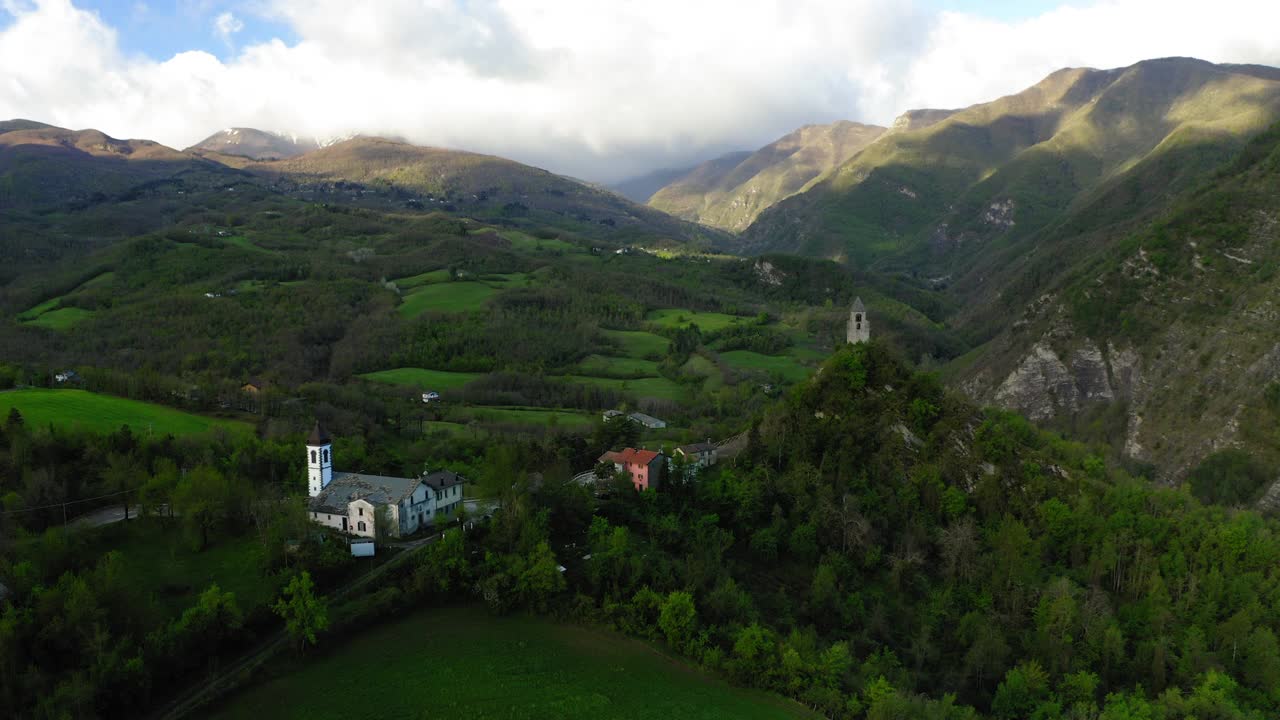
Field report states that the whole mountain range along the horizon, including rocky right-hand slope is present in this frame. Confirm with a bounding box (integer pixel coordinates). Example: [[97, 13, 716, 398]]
[[0, 58, 1280, 486]]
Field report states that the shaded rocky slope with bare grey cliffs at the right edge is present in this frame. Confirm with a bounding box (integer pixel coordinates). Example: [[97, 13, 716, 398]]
[[956, 119, 1280, 486]]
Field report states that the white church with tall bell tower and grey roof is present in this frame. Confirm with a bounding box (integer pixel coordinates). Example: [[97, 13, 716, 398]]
[[307, 423, 466, 539]]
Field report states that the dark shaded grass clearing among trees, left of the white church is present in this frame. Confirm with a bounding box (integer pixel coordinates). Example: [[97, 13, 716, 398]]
[[88, 518, 279, 616]]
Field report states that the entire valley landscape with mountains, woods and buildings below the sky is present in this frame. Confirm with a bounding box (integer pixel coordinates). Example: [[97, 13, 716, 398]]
[[0, 41, 1280, 720]]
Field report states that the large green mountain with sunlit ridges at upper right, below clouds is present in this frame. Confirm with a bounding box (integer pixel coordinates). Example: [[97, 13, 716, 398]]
[[741, 58, 1280, 267]]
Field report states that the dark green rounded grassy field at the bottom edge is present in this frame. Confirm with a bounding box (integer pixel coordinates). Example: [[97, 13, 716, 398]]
[[207, 607, 813, 720]]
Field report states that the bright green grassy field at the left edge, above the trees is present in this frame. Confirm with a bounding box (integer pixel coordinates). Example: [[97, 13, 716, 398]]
[[0, 388, 250, 436]]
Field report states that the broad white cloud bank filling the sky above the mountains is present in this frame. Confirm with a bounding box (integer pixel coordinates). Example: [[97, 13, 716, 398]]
[[0, 0, 1280, 179]]
